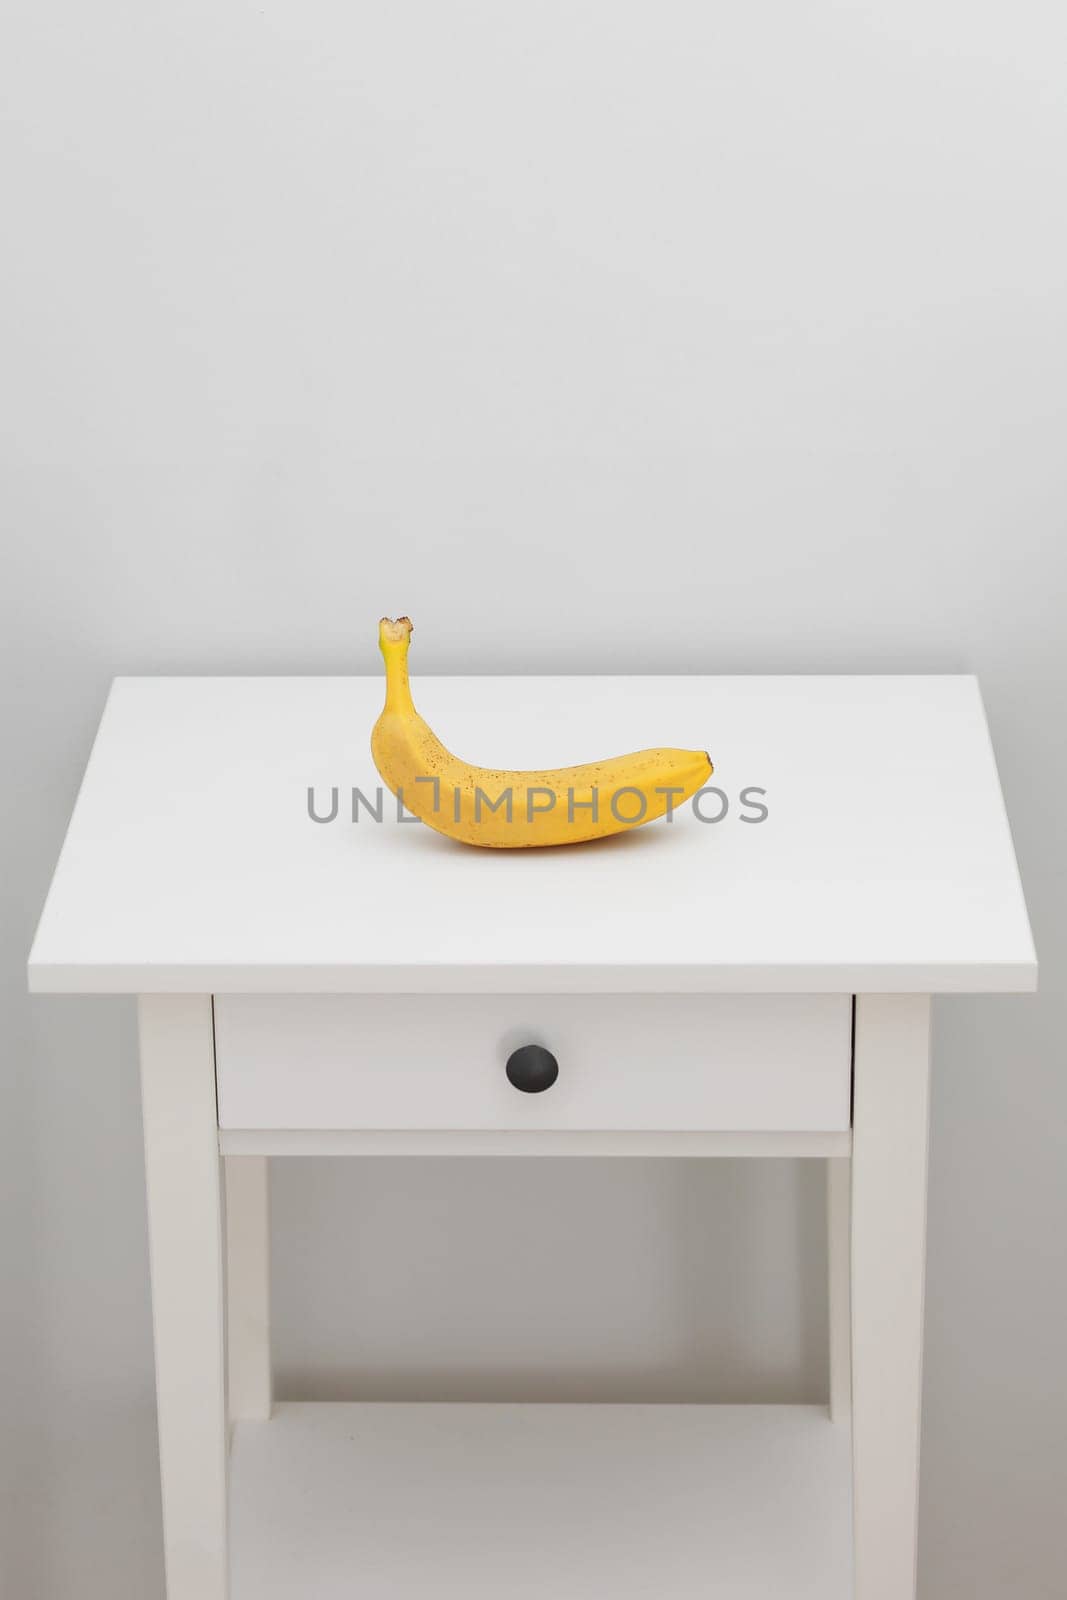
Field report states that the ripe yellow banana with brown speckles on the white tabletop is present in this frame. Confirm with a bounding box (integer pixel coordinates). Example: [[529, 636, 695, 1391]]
[[371, 616, 712, 850]]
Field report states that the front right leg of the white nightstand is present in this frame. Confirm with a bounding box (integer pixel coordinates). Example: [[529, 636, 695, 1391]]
[[853, 995, 929, 1600]]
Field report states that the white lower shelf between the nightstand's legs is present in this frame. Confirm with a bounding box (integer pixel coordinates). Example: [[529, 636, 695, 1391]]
[[230, 1403, 851, 1600]]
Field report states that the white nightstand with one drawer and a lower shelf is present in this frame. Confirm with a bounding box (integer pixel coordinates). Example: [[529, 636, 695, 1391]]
[[30, 677, 1037, 1600]]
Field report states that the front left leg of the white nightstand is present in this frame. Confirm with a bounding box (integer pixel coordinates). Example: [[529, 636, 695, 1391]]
[[139, 995, 229, 1600]]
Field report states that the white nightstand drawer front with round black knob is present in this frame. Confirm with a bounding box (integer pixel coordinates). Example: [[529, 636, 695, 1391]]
[[214, 995, 853, 1133]]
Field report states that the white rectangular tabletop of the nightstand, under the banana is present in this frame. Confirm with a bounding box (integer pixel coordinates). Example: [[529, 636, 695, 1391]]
[[30, 677, 1037, 994]]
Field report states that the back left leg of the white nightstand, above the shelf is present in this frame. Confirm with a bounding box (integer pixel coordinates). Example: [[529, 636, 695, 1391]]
[[224, 1155, 272, 1422]]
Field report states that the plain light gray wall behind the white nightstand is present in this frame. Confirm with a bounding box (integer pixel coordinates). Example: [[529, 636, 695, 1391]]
[[0, 0, 1067, 1600]]
